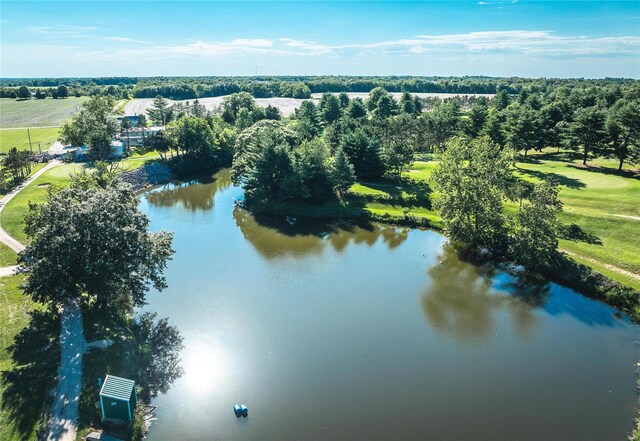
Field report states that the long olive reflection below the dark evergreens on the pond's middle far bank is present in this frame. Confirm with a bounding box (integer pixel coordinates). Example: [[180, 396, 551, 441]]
[[233, 208, 410, 259]]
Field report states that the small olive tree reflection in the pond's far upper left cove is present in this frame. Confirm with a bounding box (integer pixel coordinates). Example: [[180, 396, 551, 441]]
[[145, 169, 231, 211]]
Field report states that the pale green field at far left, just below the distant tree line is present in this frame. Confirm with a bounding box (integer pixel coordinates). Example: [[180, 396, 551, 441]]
[[0, 97, 89, 129]]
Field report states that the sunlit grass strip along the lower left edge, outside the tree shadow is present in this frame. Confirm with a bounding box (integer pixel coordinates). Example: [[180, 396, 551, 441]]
[[0, 275, 42, 441]]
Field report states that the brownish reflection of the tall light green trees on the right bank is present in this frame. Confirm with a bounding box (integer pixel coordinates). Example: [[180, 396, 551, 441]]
[[422, 244, 549, 344]]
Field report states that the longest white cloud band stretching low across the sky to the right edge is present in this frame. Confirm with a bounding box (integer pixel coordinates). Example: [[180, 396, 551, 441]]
[[46, 30, 640, 66]]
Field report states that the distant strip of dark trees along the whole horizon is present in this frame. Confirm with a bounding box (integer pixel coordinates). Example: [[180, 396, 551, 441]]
[[0, 76, 637, 100]]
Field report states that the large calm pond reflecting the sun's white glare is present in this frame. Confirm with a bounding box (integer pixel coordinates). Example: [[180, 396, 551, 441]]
[[141, 171, 640, 441]]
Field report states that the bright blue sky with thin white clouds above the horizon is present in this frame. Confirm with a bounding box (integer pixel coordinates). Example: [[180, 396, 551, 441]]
[[0, 0, 640, 78]]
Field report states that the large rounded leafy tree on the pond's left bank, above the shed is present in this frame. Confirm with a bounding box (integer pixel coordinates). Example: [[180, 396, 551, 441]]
[[24, 181, 173, 306]]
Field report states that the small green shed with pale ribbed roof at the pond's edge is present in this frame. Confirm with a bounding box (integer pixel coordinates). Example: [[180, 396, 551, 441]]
[[100, 375, 138, 422]]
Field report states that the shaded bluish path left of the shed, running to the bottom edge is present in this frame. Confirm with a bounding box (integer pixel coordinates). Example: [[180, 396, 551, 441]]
[[47, 300, 87, 441]]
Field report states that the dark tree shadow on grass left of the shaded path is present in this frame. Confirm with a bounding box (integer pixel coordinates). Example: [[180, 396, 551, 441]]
[[0, 311, 60, 440]]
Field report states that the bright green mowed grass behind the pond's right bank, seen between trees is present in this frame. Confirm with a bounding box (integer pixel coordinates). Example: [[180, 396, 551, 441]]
[[352, 153, 640, 290]]
